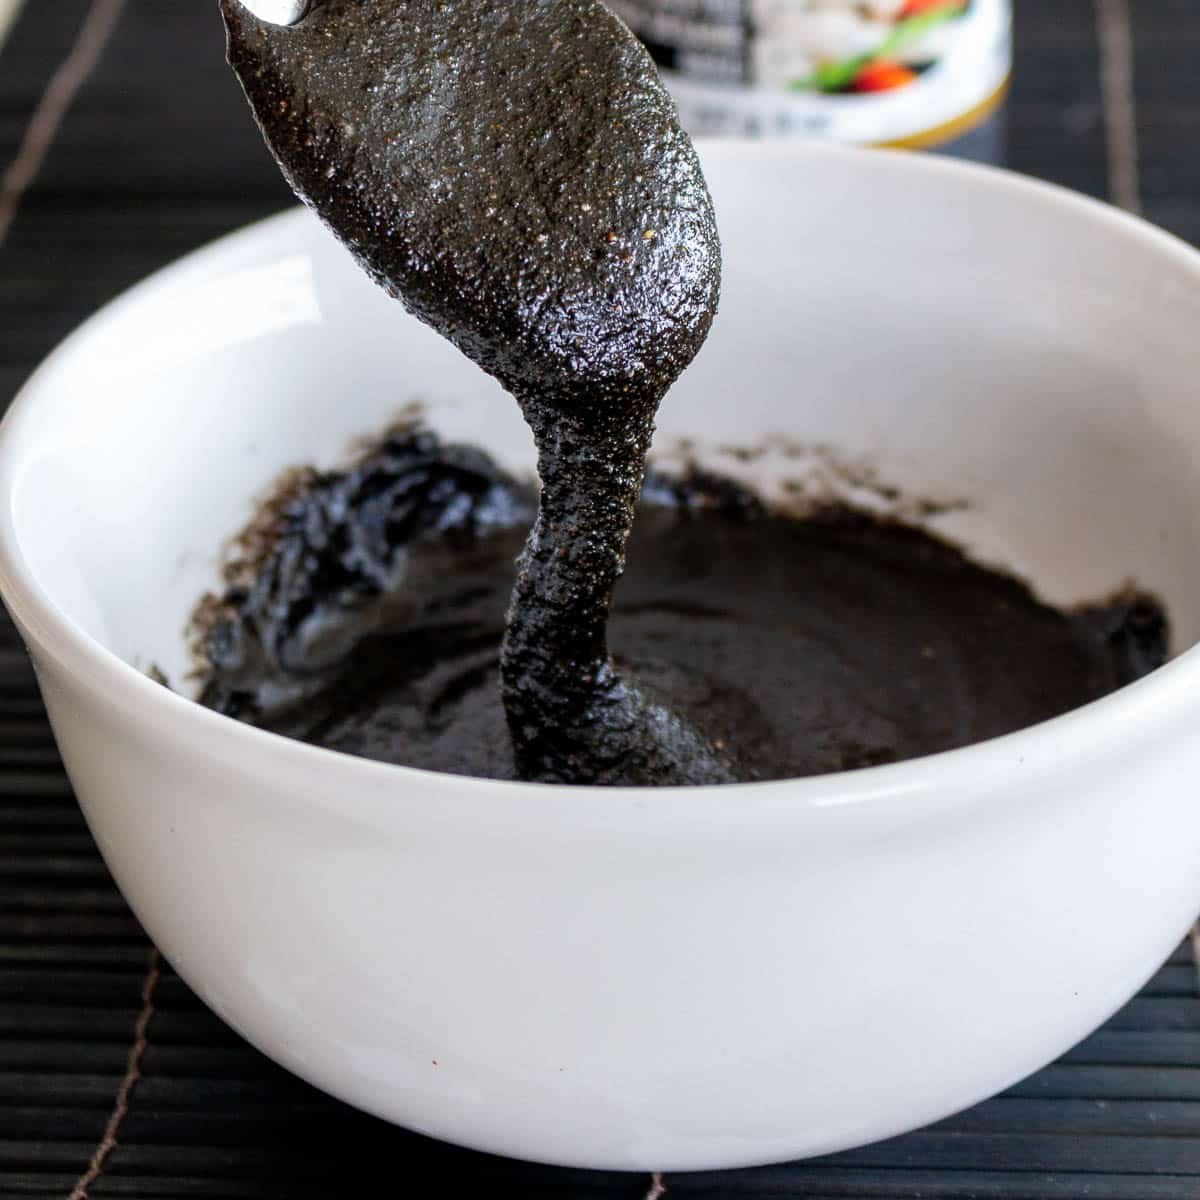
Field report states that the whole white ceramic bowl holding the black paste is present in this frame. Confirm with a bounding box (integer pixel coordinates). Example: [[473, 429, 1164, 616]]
[[0, 145, 1200, 1169]]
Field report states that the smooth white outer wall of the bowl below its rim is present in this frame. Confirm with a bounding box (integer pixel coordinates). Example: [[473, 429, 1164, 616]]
[[28, 643, 1200, 1170]]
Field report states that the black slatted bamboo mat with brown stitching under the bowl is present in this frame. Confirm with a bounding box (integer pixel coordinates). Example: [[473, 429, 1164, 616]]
[[0, 0, 1200, 1200]]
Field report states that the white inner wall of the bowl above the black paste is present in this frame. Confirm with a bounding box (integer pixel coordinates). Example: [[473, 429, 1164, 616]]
[[2, 144, 1200, 696]]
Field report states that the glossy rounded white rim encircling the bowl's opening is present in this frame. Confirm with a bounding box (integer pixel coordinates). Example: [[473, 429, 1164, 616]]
[[0, 139, 1200, 824]]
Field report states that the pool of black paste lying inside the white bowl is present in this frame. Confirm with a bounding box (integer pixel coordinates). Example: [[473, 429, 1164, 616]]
[[197, 431, 1166, 780]]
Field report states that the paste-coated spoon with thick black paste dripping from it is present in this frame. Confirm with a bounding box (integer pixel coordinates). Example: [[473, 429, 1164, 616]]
[[222, 0, 732, 785]]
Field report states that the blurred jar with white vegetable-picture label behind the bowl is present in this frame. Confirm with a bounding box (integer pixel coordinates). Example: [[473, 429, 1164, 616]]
[[608, 0, 1013, 162]]
